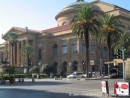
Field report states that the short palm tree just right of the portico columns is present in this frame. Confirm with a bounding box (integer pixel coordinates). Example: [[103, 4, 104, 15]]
[[21, 45, 33, 73]]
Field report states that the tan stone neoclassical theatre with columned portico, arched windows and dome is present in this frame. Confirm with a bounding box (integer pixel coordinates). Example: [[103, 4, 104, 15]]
[[0, 0, 130, 73]]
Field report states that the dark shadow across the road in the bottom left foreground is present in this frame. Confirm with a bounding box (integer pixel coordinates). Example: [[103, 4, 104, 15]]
[[0, 88, 99, 98]]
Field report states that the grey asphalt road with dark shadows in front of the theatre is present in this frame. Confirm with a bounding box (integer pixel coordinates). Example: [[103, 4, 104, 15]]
[[0, 79, 126, 98]]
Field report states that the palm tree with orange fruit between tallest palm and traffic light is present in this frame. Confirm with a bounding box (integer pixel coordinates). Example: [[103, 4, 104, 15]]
[[99, 14, 124, 75]]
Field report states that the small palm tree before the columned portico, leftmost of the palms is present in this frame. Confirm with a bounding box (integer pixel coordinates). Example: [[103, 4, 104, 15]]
[[7, 32, 18, 66]]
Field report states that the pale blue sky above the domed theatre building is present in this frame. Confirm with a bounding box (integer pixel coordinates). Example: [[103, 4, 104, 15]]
[[0, 0, 130, 43]]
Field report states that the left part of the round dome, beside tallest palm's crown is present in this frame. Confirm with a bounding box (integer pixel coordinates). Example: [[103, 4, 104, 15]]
[[55, 0, 88, 26]]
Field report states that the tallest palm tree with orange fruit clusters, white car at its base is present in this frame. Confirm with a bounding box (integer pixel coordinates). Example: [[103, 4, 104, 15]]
[[70, 5, 101, 78]]
